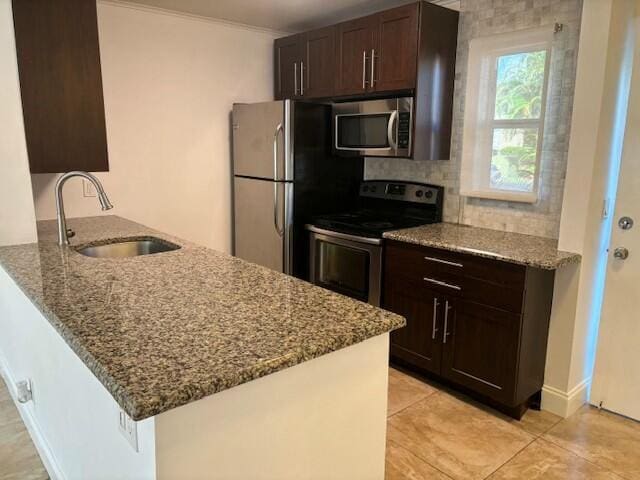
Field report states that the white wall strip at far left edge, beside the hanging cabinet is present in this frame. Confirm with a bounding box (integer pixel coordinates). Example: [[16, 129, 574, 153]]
[[0, 0, 36, 245]]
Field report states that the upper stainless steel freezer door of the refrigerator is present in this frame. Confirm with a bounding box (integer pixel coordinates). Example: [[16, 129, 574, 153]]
[[233, 100, 293, 180]]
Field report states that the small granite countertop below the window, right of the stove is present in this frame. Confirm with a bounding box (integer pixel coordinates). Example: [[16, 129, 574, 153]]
[[384, 223, 581, 270]]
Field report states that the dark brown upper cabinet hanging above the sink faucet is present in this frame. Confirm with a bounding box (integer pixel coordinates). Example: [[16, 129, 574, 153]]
[[13, 0, 109, 173]]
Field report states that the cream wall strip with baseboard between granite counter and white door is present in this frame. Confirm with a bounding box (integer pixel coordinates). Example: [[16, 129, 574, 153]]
[[543, 0, 628, 415]]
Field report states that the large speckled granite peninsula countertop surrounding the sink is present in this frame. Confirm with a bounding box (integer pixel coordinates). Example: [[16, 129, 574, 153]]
[[0, 216, 405, 420]]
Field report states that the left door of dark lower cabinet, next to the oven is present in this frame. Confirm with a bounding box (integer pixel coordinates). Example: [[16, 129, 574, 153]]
[[384, 278, 443, 374]]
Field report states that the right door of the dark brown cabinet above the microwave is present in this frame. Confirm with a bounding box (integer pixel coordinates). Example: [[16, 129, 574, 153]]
[[372, 3, 419, 91]]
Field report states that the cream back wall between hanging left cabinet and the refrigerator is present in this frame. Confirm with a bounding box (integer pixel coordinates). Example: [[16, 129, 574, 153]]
[[32, 1, 279, 252]]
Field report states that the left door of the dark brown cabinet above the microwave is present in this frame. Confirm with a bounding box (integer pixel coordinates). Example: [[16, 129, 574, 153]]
[[336, 16, 377, 95]]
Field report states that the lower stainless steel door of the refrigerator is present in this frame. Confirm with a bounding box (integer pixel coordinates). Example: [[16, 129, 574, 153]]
[[234, 177, 293, 273]]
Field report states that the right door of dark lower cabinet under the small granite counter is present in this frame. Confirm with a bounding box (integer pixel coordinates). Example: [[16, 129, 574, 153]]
[[442, 299, 521, 406]]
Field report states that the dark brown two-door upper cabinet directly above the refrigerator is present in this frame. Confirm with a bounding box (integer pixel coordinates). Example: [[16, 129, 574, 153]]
[[274, 27, 336, 100]]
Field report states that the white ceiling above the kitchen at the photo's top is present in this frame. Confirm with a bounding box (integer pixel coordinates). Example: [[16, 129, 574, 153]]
[[120, 0, 460, 32]]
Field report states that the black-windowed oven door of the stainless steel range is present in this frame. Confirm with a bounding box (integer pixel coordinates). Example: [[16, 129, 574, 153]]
[[307, 225, 382, 306]]
